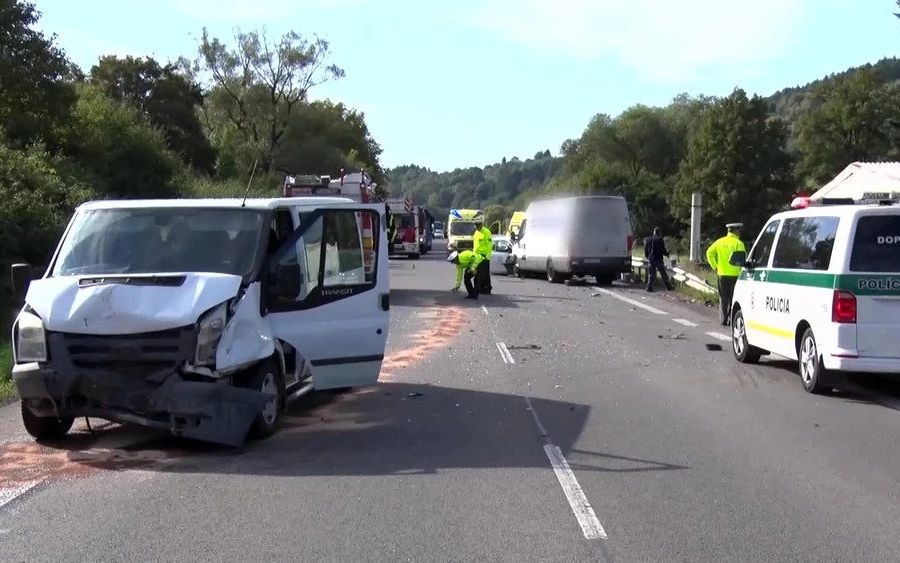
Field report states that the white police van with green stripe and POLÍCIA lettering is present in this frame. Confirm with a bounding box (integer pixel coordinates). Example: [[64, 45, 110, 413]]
[[731, 194, 900, 393]]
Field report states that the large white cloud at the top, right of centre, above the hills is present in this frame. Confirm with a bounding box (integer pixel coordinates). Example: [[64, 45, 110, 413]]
[[466, 0, 807, 82]]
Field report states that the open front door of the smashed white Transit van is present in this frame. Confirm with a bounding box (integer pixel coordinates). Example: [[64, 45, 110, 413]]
[[262, 203, 390, 389]]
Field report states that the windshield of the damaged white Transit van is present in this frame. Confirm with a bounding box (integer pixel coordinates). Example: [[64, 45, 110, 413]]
[[51, 207, 266, 281]]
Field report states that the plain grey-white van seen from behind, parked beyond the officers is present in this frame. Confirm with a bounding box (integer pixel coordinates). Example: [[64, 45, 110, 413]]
[[513, 195, 634, 285]]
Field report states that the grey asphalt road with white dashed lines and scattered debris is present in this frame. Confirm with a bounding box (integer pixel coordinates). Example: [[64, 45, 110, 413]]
[[0, 240, 900, 562]]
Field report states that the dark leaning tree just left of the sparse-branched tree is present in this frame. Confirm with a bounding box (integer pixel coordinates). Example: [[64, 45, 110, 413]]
[[90, 56, 216, 174]]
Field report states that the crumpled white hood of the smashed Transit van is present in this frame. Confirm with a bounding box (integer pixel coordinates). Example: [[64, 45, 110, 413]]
[[25, 273, 242, 334]]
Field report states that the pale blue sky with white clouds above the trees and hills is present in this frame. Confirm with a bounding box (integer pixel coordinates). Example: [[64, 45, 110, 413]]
[[32, 0, 900, 173]]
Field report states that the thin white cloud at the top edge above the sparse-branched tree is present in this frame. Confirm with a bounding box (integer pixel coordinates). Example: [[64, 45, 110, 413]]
[[172, 0, 367, 24]]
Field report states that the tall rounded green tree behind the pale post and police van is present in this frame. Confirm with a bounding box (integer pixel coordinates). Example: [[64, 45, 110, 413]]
[[672, 89, 793, 236]]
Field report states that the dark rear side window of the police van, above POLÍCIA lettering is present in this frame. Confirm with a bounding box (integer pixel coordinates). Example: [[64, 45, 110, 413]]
[[772, 217, 840, 270]]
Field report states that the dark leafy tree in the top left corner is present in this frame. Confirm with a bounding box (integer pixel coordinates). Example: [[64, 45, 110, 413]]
[[0, 0, 75, 146]]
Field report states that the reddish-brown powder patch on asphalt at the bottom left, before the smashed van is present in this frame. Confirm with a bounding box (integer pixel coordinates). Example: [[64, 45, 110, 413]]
[[0, 442, 176, 489]]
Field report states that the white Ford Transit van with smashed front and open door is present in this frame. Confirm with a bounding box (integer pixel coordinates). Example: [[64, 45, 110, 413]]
[[12, 197, 390, 446]]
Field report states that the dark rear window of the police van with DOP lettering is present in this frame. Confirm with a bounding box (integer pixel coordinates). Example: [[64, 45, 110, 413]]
[[850, 215, 900, 273]]
